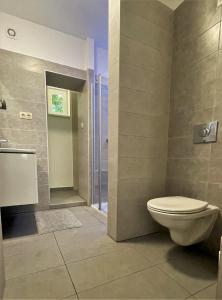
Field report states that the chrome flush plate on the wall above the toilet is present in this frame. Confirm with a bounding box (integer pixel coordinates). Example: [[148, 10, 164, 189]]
[[193, 121, 218, 144]]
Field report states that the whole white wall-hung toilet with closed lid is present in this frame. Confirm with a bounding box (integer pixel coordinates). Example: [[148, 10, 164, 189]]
[[147, 196, 219, 246]]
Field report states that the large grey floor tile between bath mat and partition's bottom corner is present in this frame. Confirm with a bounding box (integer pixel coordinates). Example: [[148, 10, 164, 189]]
[[55, 223, 119, 262]]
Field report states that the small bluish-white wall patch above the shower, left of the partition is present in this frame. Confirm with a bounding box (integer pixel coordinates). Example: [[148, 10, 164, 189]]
[[95, 48, 108, 78]]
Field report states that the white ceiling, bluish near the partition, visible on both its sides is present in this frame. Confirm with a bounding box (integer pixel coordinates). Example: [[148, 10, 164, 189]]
[[0, 0, 183, 48]]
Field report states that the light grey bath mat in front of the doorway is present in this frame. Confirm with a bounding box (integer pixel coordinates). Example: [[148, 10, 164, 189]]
[[35, 209, 82, 234]]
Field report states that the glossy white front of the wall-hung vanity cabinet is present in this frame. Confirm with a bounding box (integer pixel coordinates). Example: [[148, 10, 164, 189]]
[[0, 153, 38, 207]]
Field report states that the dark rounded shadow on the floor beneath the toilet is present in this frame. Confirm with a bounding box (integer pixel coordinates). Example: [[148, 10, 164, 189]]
[[167, 244, 218, 280]]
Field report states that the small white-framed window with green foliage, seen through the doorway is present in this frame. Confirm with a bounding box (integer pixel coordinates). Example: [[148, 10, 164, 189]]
[[47, 86, 70, 117]]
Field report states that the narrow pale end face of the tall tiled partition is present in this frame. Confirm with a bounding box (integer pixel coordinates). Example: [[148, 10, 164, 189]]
[[108, 0, 120, 239]]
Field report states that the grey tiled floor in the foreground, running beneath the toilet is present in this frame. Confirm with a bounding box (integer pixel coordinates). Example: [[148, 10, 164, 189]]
[[4, 207, 217, 299]]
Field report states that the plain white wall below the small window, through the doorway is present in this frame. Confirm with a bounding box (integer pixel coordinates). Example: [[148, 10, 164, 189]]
[[48, 115, 73, 188]]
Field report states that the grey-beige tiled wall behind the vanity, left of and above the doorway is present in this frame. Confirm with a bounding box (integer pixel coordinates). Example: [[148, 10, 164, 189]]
[[0, 50, 87, 209]]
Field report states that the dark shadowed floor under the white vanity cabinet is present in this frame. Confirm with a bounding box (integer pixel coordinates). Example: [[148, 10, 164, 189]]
[[2, 212, 38, 239]]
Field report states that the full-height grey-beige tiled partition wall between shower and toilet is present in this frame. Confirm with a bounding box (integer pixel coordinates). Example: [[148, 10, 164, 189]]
[[109, 0, 173, 240]]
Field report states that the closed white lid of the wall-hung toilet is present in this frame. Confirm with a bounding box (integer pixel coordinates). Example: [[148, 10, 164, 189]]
[[147, 196, 208, 214]]
